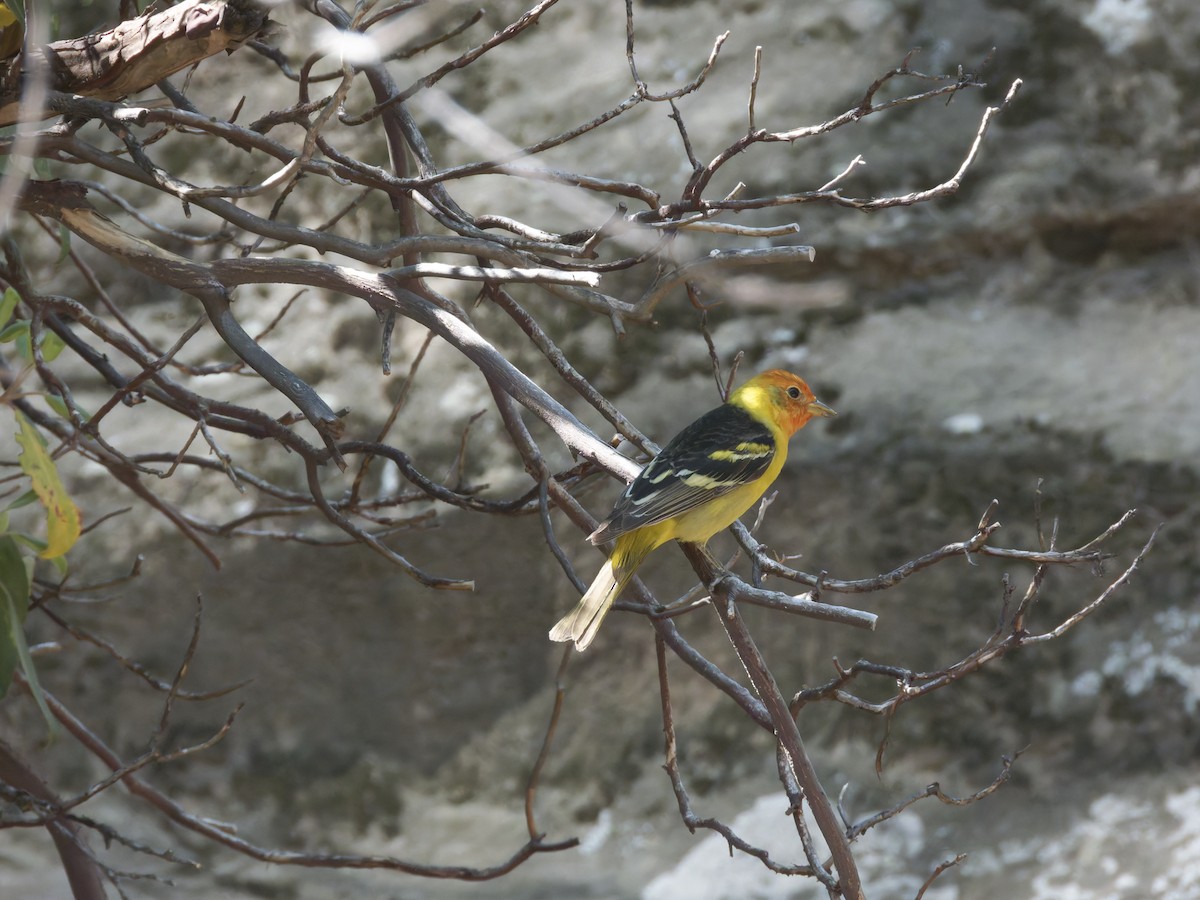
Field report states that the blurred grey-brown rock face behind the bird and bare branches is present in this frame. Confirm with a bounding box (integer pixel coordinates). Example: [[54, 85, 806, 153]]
[[0, 0, 1200, 900]]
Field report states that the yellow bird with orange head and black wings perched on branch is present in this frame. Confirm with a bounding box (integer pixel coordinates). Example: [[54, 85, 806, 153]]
[[550, 368, 836, 650]]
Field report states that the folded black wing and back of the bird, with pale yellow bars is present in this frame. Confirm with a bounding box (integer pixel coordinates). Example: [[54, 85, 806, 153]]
[[592, 404, 775, 544]]
